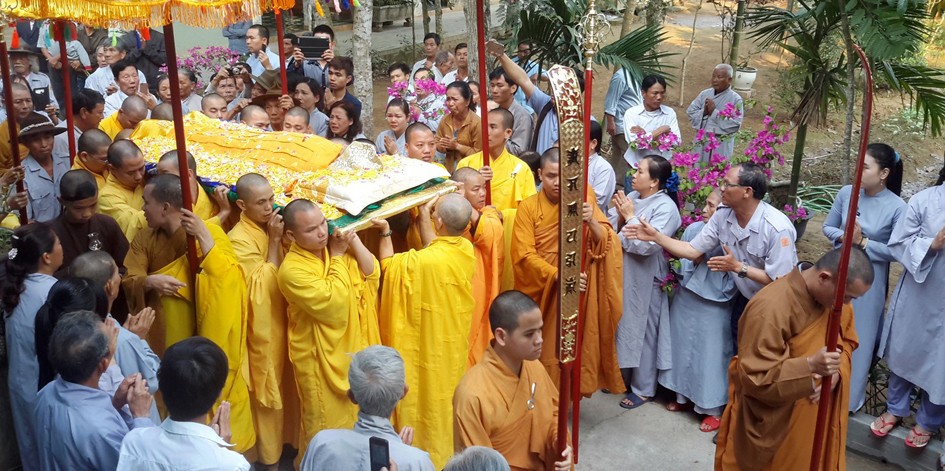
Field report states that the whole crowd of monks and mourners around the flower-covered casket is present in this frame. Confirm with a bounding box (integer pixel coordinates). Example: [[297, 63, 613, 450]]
[[0, 16, 945, 471]]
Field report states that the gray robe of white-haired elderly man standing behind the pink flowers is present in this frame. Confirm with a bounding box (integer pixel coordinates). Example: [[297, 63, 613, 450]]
[[686, 87, 745, 165]]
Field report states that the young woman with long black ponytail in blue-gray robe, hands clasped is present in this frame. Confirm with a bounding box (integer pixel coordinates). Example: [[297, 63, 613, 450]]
[[823, 143, 906, 412]]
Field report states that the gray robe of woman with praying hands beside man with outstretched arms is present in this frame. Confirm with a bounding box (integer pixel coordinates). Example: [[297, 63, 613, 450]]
[[617, 191, 682, 370]]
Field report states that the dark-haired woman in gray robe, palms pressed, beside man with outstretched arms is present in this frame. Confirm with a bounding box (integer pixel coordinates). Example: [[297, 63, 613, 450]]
[[614, 156, 682, 409]]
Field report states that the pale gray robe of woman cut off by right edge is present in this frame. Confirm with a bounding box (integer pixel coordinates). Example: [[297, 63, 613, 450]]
[[880, 184, 945, 405]]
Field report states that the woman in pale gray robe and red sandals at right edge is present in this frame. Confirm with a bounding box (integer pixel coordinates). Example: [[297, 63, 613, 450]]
[[871, 171, 945, 448]]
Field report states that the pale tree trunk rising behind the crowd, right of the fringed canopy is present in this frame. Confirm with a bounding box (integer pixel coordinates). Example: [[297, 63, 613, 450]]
[[351, 0, 374, 136]]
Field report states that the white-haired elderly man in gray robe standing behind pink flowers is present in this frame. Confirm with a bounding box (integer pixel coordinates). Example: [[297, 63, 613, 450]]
[[686, 64, 745, 165]]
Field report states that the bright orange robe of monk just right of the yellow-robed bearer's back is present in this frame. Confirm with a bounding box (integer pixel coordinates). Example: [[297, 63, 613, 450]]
[[463, 206, 505, 367]]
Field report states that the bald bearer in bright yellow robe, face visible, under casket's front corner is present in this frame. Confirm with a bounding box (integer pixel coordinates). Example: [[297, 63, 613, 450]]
[[279, 200, 381, 463]]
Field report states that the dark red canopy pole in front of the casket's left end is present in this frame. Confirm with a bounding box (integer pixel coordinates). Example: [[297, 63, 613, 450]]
[[164, 19, 198, 276]]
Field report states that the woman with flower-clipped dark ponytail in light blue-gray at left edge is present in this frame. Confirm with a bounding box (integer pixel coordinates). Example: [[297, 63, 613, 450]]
[[0, 223, 62, 469]]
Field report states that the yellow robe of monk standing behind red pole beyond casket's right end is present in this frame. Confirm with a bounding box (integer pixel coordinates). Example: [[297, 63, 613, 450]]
[[456, 150, 537, 211]]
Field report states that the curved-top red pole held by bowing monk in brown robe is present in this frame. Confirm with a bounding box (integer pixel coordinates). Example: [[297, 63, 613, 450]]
[[810, 44, 873, 471]]
